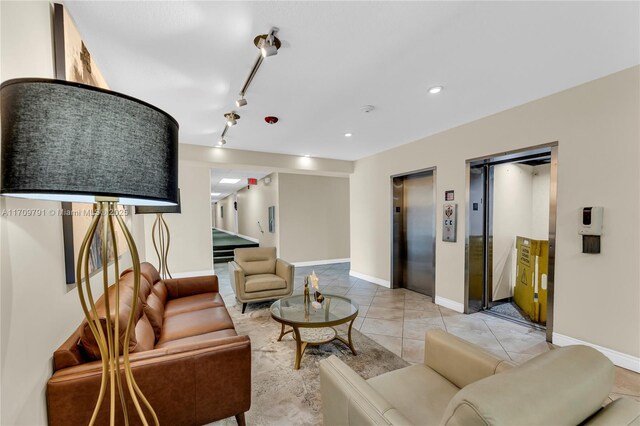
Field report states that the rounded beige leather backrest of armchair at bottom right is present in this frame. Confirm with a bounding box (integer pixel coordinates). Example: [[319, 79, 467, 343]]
[[442, 346, 615, 425]]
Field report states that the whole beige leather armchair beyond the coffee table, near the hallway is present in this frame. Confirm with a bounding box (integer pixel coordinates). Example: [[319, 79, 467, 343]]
[[229, 247, 294, 314]]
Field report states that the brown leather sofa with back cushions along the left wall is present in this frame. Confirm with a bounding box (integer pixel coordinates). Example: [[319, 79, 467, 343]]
[[47, 263, 251, 426]]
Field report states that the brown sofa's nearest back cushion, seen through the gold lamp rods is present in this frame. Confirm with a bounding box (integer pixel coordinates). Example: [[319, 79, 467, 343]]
[[80, 274, 146, 360]]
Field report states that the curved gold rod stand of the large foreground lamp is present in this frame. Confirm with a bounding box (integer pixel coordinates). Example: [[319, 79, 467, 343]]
[[76, 197, 159, 426]]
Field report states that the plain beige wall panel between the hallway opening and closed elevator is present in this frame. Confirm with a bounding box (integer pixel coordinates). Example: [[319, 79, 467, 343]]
[[277, 173, 350, 262]]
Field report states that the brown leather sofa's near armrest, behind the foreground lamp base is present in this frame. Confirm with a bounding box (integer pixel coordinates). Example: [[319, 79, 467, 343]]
[[47, 336, 251, 426]]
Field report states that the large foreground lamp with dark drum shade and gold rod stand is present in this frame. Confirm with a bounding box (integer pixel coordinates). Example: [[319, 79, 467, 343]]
[[0, 79, 178, 425]]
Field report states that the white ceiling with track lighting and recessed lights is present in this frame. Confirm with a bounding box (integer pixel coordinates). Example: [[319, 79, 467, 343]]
[[64, 1, 640, 160]]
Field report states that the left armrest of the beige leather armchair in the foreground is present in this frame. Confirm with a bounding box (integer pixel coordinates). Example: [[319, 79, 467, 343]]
[[320, 355, 410, 426]]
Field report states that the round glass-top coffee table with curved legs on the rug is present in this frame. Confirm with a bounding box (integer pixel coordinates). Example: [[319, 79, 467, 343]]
[[271, 294, 358, 370]]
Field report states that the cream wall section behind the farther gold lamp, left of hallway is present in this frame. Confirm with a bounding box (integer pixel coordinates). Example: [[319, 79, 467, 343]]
[[142, 161, 213, 274]]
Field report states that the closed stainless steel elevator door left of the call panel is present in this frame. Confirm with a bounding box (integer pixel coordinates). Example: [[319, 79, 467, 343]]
[[399, 172, 435, 297]]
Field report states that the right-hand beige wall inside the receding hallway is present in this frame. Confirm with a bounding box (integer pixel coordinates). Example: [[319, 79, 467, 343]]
[[236, 173, 280, 247]]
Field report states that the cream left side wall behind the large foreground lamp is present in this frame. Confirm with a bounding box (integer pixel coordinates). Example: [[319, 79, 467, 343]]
[[0, 1, 145, 425]]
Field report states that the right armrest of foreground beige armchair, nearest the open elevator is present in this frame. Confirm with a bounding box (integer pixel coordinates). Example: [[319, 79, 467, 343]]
[[424, 330, 515, 388]]
